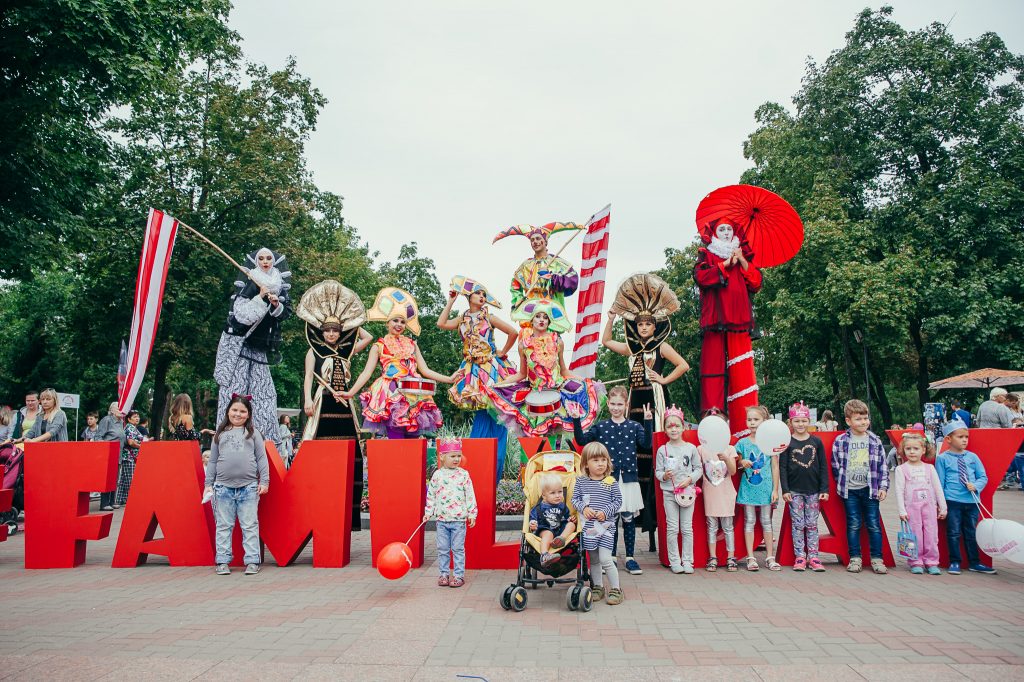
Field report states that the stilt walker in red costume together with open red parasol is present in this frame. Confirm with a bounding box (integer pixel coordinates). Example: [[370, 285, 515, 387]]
[[693, 184, 804, 437]]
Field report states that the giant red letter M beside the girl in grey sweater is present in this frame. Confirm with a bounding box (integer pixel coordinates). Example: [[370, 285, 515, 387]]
[[259, 440, 354, 568]]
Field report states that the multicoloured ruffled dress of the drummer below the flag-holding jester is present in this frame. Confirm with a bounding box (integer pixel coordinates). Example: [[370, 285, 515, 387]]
[[484, 327, 604, 436]]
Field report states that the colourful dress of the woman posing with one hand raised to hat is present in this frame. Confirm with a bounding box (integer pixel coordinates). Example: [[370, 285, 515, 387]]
[[449, 306, 515, 411]]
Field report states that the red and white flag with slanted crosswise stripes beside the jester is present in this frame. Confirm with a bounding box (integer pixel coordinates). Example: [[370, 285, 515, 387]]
[[569, 204, 611, 379]]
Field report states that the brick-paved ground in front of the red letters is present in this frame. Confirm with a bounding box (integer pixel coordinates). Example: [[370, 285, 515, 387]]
[[0, 491, 1024, 682]]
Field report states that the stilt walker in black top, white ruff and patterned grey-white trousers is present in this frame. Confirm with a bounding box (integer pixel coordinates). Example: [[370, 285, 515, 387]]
[[213, 248, 292, 453]]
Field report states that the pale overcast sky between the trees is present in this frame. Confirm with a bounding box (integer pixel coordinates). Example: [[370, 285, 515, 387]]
[[230, 0, 1024, 339]]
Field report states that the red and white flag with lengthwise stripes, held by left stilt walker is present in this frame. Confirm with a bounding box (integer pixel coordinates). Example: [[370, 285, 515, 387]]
[[118, 209, 178, 413]]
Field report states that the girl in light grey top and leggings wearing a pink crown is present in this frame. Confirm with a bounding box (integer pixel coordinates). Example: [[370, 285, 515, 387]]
[[654, 406, 702, 573]]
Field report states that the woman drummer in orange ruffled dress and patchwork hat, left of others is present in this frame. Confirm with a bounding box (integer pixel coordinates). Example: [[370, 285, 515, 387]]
[[341, 287, 454, 438]]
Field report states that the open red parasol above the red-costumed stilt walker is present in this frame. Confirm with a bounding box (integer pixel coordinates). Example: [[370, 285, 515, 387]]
[[696, 184, 804, 267]]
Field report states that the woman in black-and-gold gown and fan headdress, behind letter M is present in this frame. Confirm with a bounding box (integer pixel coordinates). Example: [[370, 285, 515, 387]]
[[295, 280, 374, 530]]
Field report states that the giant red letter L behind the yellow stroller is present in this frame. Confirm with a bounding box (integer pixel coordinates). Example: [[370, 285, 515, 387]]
[[462, 438, 519, 568]]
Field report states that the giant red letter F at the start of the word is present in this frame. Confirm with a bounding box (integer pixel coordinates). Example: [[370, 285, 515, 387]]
[[25, 442, 119, 568]]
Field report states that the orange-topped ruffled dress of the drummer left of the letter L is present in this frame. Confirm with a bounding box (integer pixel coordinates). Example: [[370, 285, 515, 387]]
[[359, 334, 442, 435]]
